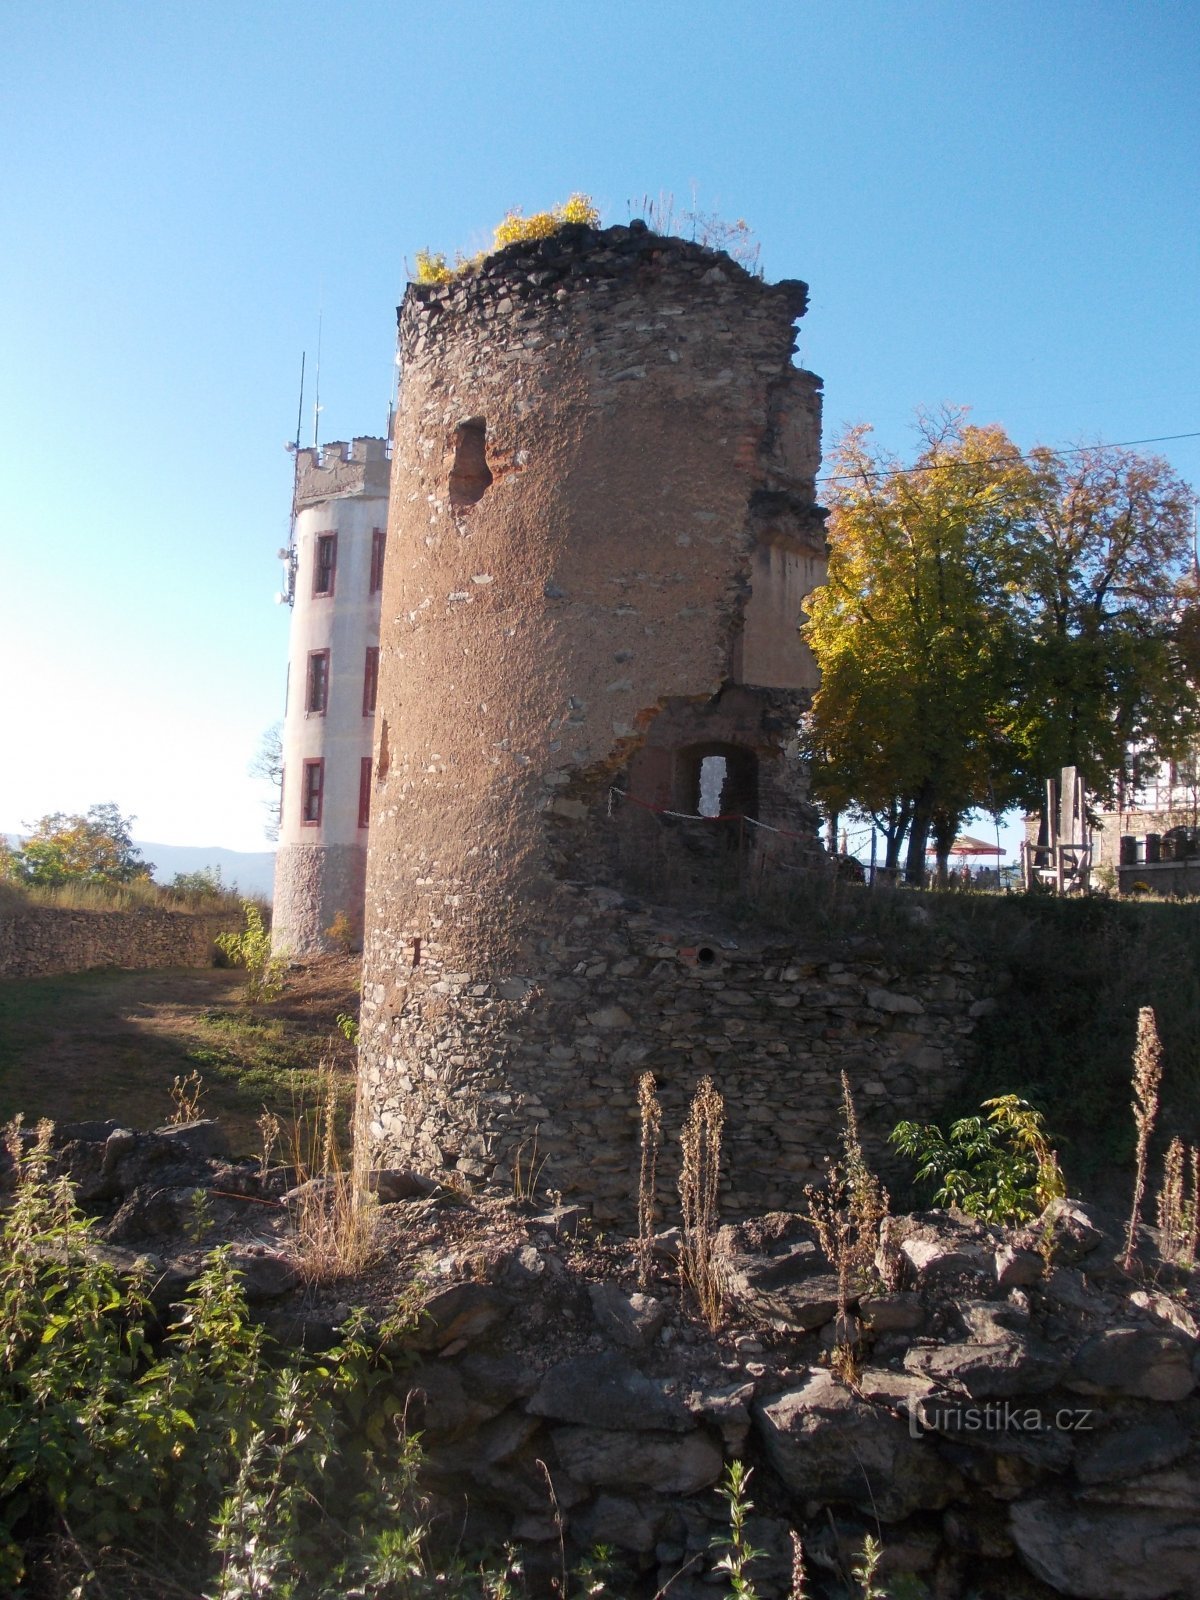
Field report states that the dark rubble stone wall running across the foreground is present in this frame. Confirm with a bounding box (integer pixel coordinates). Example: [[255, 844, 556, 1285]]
[[11, 1123, 1200, 1600]]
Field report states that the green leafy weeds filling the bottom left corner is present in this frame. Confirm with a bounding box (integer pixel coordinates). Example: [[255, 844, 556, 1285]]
[[0, 1123, 428, 1600]]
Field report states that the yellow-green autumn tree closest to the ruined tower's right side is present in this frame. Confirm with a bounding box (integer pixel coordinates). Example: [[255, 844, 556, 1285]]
[[805, 411, 1030, 882]]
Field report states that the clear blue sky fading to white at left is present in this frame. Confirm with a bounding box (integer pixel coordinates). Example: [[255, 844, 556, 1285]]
[[0, 0, 1200, 850]]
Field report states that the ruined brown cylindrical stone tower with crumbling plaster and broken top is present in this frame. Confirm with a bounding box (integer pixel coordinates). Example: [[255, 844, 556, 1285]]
[[360, 224, 826, 1214]]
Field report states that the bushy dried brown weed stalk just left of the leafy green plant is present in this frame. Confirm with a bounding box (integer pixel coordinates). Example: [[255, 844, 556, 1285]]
[[805, 1072, 888, 1382]]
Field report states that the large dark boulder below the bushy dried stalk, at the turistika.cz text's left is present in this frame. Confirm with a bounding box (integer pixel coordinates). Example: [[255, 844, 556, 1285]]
[[755, 1370, 958, 1522]]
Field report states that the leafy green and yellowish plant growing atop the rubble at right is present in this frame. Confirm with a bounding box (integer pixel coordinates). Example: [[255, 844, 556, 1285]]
[[890, 1094, 1067, 1224]]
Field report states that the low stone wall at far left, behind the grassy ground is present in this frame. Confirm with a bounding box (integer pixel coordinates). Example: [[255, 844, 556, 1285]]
[[0, 906, 242, 978]]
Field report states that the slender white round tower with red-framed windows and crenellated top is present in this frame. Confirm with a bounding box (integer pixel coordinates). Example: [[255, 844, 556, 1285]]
[[274, 438, 390, 955]]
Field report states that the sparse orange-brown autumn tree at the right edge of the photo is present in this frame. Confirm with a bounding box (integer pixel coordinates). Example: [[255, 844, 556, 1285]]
[[1013, 446, 1200, 805]]
